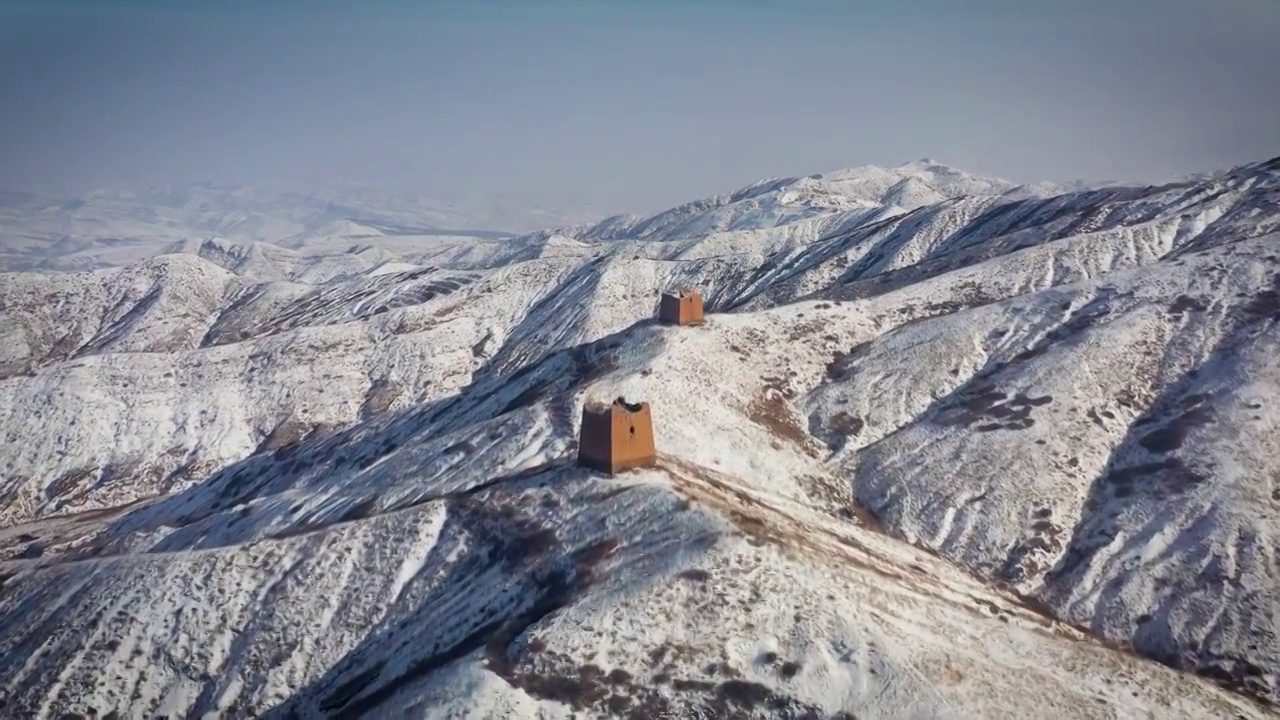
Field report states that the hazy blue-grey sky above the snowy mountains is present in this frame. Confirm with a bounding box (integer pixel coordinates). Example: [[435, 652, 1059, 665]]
[[0, 0, 1280, 211]]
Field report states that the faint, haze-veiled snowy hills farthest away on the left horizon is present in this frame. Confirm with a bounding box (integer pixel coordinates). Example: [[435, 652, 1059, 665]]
[[0, 183, 599, 275]]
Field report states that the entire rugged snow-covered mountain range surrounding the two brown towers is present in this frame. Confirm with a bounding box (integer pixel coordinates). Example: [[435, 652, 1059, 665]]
[[0, 159, 1280, 719]]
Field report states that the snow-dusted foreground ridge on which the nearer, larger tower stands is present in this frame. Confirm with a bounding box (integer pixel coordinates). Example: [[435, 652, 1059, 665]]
[[0, 316, 1261, 717]]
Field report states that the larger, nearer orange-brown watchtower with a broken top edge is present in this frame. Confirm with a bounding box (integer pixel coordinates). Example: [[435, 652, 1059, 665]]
[[577, 397, 658, 475]]
